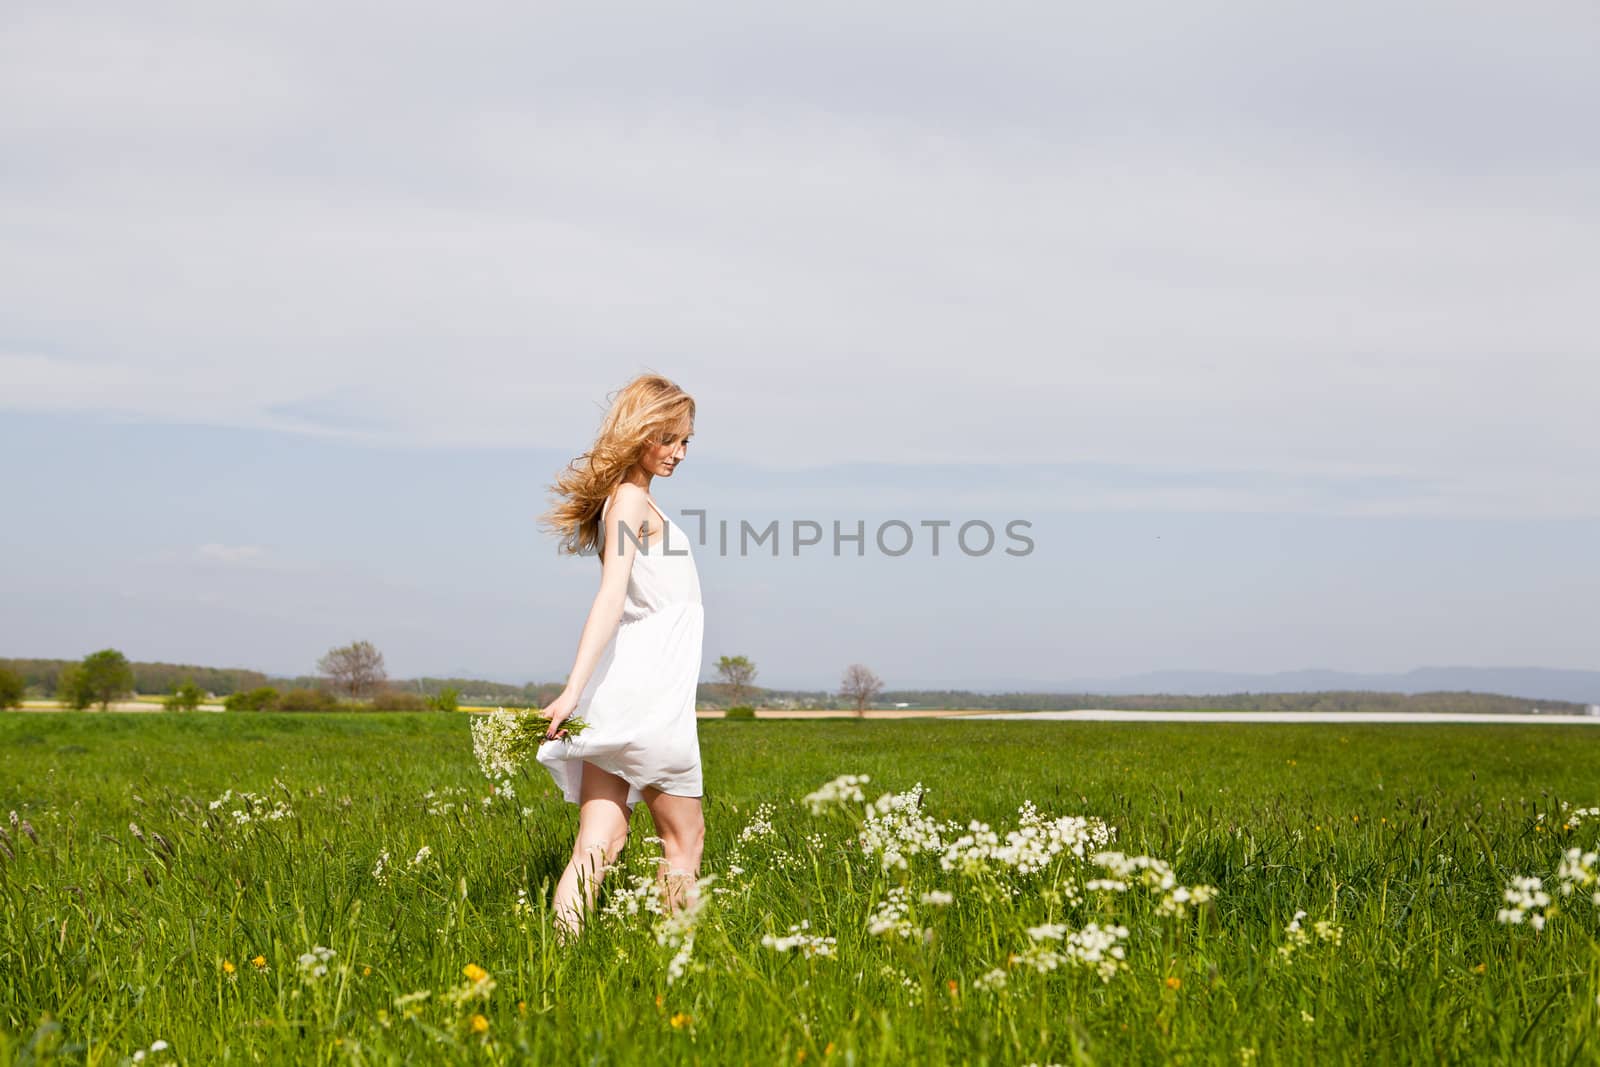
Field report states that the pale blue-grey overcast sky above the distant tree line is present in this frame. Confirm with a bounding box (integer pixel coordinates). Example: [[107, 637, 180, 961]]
[[0, 2, 1600, 688]]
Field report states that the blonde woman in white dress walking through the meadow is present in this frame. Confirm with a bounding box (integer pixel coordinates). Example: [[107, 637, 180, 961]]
[[539, 374, 706, 939]]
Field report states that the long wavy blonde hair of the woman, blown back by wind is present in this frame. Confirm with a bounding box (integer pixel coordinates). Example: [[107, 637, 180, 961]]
[[539, 374, 694, 555]]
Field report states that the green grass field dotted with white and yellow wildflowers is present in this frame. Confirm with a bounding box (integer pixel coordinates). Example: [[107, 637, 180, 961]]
[[0, 712, 1600, 1064]]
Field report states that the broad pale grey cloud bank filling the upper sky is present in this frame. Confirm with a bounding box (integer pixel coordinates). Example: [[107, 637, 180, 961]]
[[0, 3, 1600, 515]]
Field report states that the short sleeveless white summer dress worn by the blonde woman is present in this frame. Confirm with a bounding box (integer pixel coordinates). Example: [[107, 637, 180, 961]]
[[538, 499, 706, 811]]
